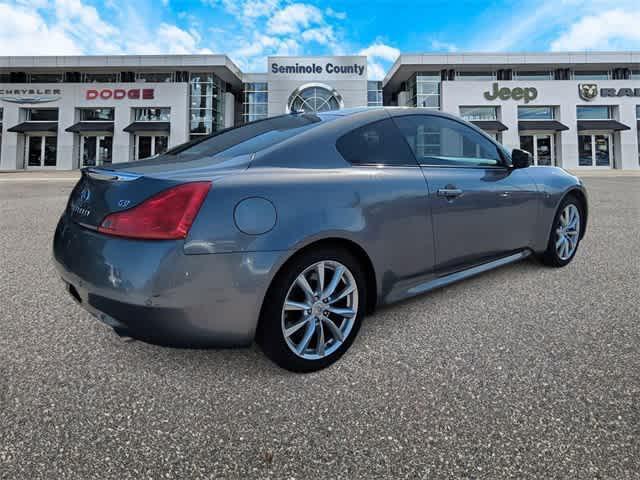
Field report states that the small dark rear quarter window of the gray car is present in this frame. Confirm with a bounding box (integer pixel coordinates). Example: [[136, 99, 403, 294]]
[[336, 119, 416, 166]]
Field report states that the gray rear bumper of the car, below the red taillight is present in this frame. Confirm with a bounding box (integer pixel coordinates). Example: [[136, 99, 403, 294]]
[[53, 216, 284, 346]]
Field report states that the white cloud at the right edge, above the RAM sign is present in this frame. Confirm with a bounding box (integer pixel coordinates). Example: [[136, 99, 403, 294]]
[[551, 9, 640, 51]]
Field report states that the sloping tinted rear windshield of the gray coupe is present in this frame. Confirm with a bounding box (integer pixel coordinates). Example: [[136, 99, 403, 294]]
[[166, 113, 323, 161]]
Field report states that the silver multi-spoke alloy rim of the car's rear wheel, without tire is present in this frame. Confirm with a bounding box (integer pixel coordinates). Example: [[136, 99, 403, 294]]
[[282, 260, 358, 360]]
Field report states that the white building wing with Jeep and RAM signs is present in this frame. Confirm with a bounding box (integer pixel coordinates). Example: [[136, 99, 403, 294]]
[[384, 52, 640, 170]]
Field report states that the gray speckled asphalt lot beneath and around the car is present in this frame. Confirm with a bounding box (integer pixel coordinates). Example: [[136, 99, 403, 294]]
[[0, 177, 640, 479]]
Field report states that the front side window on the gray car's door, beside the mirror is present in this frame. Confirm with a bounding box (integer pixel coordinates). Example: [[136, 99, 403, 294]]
[[395, 115, 502, 167]]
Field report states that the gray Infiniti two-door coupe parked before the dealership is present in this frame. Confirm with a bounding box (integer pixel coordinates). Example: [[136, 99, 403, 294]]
[[53, 108, 587, 371]]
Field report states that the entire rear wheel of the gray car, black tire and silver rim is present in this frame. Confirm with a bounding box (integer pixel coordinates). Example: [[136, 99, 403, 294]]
[[257, 248, 366, 372]]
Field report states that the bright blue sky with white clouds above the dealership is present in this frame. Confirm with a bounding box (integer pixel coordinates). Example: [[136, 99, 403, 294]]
[[0, 0, 640, 78]]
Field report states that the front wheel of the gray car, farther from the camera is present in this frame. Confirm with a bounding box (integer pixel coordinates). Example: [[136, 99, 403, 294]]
[[542, 196, 583, 267]]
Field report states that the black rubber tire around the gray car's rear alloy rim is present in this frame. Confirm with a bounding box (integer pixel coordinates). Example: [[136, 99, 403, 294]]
[[256, 246, 367, 372]]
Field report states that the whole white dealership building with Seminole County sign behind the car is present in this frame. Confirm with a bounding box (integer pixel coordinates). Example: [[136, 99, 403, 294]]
[[0, 52, 640, 170]]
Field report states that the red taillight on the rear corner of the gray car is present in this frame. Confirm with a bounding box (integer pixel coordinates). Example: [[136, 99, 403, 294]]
[[98, 182, 211, 240]]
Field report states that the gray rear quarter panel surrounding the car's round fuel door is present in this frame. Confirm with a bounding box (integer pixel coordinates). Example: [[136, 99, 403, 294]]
[[185, 166, 434, 308]]
